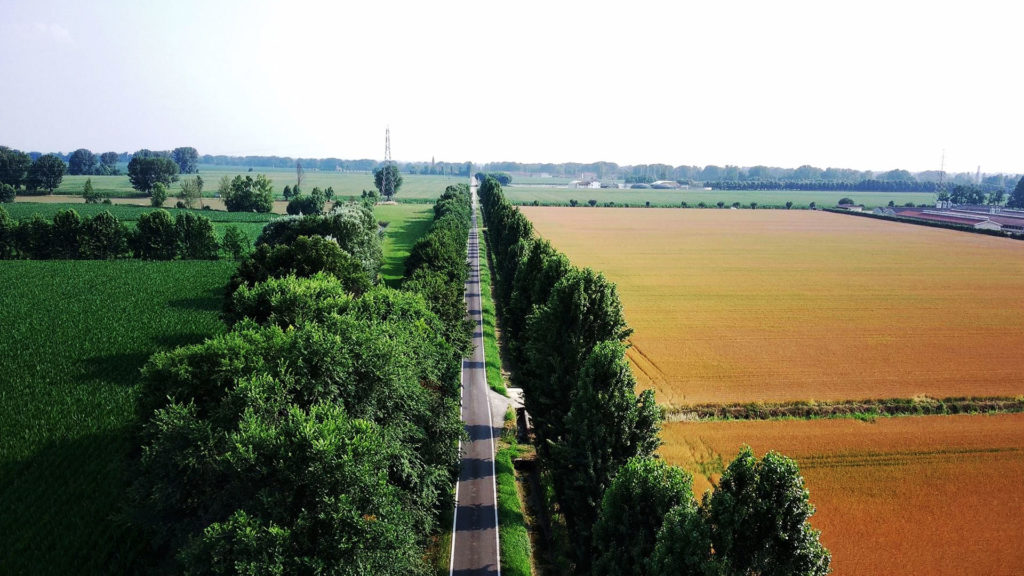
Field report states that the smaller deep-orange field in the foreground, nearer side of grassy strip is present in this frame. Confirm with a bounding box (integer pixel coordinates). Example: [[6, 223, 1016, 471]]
[[660, 414, 1024, 575]]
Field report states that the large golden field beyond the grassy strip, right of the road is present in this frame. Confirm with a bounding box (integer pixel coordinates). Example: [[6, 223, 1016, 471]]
[[522, 207, 1024, 404]]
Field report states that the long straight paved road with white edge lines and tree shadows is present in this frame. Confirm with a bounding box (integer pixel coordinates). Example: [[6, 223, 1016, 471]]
[[451, 188, 501, 576]]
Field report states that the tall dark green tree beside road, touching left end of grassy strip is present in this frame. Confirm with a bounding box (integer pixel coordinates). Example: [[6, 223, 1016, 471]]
[[549, 341, 662, 567]]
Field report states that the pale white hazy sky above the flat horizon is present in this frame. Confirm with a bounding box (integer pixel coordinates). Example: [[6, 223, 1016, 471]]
[[0, 0, 1024, 173]]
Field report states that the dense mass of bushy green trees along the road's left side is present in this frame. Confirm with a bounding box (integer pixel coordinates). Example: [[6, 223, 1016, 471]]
[[128, 195, 468, 575]]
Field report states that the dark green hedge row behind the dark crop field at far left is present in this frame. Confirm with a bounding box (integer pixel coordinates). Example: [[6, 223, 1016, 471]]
[[0, 204, 234, 260]]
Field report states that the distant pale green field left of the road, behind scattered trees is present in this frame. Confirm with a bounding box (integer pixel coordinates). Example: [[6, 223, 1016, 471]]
[[46, 164, 467, 204]]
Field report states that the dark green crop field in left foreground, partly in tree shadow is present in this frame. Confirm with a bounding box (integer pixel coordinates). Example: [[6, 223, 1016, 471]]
[[0, 260, 236, 574]]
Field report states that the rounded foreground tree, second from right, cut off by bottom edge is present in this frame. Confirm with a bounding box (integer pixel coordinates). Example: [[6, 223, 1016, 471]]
[[592, 458, 695, 576]]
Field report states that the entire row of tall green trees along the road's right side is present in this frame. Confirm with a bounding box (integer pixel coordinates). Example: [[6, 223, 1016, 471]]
[[479, 177, 830, 575]]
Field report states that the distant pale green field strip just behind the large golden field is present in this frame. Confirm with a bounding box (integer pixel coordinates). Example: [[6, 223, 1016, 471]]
[[495, 186, 935, 208]]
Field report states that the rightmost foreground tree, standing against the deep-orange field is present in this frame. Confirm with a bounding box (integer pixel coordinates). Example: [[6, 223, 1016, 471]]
[[708, 447, 831, 576]]
